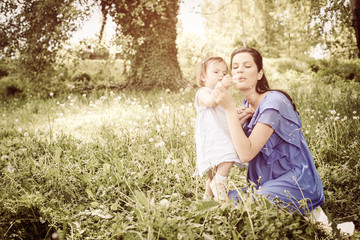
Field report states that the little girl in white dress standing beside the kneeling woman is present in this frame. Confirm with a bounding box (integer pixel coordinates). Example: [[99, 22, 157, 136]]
[[195, 57, 246, 201]]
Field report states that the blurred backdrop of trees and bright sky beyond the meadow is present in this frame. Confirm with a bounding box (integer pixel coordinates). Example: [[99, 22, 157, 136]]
[[0, 0, 359, 97]]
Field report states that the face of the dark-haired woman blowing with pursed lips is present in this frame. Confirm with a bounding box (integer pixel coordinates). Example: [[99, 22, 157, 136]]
[[231, 52, 263, 90]]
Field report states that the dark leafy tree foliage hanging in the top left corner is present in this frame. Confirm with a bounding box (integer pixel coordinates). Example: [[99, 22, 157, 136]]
[[0, 0, 78, 80]]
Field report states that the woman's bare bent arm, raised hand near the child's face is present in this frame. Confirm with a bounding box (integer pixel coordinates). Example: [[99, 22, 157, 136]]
[[214, 83, 274, 162]]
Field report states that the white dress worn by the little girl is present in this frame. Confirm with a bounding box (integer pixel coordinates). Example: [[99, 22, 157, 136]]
[[194, 87, 247, 176]]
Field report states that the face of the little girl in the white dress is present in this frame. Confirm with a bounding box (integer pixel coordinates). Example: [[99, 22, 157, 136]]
[[203, 61, 227, 89]]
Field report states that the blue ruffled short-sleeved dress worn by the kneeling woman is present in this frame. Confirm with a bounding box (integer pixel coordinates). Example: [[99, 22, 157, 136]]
[[229, 91, 325, 214]]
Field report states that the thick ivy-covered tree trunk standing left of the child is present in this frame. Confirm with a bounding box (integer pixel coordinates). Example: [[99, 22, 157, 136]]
[[99, 0, 184, 90]]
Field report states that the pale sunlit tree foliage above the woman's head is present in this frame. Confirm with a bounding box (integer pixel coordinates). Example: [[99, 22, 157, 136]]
[[202, 0, 356, 57]]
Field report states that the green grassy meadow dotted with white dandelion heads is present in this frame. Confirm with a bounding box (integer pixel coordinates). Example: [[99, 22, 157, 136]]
[[0, 60, 360, 239]]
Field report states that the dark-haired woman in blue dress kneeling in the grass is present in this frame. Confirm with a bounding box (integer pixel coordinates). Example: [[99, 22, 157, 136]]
[[213, 48, 325, 214]]
